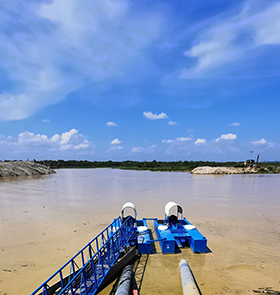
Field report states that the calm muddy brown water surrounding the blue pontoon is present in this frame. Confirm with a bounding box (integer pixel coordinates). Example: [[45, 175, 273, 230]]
[[0, 169, 280, 295]]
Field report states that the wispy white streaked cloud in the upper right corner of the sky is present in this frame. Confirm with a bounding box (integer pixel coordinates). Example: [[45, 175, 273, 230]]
[[180, 0, 280, 79]]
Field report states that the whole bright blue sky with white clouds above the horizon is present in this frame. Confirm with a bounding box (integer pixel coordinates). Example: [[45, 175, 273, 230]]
[[0, 0, 280, 161]]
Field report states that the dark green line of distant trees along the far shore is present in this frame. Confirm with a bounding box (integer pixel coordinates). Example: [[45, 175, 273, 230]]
[[29, 160, 280, 173]]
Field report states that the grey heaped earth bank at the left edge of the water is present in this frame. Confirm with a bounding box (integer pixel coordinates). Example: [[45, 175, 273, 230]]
[[0, 161, 55, 177]]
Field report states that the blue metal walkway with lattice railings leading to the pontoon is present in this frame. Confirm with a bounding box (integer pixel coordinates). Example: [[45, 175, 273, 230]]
[[31, 217, 134, 295]]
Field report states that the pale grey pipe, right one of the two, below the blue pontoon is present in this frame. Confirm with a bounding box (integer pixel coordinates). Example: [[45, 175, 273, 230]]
[[180, 259, 200, 295]]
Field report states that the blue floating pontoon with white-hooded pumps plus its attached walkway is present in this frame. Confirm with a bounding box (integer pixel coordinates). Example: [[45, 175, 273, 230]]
[[31, 202, 207, 295]]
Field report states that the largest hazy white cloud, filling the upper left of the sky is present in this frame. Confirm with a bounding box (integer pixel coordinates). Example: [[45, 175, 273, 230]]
[[0, 0, 162, 121]]
